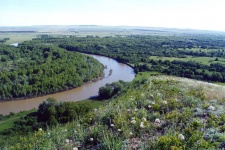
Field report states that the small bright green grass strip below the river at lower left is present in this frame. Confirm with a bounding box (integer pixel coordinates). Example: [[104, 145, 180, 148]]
[[0, 109, 36, 132]]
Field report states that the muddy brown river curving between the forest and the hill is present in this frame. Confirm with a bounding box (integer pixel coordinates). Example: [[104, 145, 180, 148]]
[[0, 55, 135, 114]]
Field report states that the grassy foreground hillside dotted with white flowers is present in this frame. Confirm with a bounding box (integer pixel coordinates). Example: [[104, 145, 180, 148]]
[[3, 74, 225, 150]]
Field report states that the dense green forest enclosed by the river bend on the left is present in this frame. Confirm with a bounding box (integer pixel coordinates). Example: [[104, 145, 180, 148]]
[[0, 43, 104, 100]]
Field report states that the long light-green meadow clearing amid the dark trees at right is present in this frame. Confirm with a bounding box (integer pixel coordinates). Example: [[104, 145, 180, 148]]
[[150, 56, 225, 65]]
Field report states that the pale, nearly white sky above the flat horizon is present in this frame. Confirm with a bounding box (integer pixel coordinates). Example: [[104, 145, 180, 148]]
[[0, 0, 225, 31]]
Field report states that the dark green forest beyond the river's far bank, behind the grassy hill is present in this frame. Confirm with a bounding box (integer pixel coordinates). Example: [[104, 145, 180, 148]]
[[25, 34, 225, 82]]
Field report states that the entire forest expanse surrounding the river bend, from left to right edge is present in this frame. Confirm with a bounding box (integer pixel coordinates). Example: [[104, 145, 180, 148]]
[[0, 34, 225, 100]]
